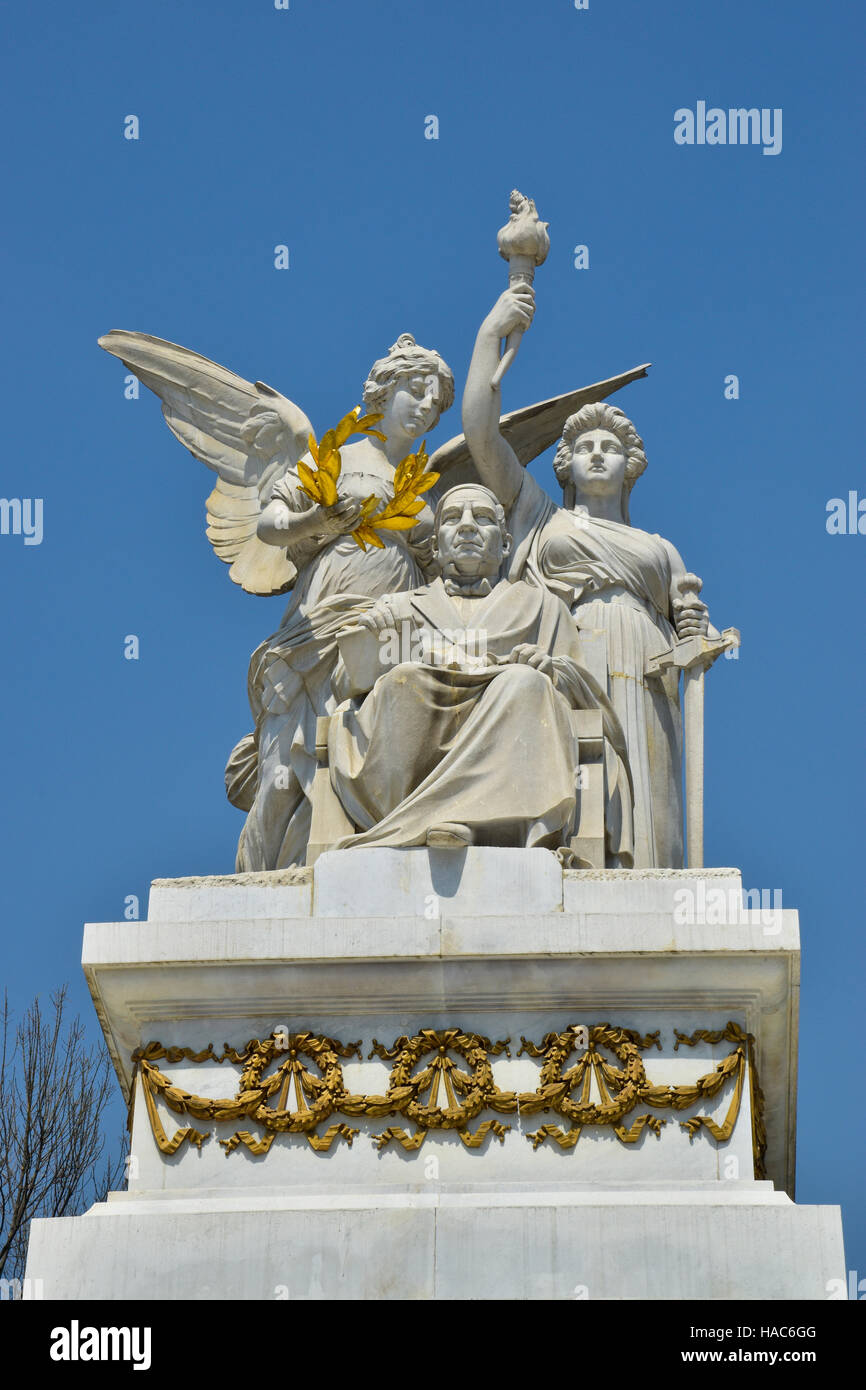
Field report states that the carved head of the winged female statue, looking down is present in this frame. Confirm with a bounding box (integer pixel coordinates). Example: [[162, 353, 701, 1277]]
[[364, 334, 455, 439]]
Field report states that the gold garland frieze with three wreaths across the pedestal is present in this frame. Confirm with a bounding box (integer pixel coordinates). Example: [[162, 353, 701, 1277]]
[[132, 1022, 766, 1177]]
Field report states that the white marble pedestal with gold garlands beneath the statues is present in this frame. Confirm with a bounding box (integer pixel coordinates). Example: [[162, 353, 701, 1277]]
[[26, 849, 845, 1301]]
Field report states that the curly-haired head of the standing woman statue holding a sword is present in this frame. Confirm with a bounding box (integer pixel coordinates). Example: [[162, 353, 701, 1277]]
[[553, 400, 646, 523]]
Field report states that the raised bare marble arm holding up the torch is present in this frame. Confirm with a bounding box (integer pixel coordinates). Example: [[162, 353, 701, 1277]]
[[463, 285, 535, 512]]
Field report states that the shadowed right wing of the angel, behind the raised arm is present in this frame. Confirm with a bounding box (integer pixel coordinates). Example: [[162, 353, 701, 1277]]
[[430, 363, 651, 493]]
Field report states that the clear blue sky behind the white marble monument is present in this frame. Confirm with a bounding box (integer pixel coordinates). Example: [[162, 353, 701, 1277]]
[[0, 0, 866, 1275]]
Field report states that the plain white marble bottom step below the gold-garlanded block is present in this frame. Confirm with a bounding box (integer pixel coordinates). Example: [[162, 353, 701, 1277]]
[[28, 1183, 845, 1302]]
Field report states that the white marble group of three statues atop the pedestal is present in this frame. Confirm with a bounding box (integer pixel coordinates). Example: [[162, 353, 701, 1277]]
[[100, 193, 735, 872]]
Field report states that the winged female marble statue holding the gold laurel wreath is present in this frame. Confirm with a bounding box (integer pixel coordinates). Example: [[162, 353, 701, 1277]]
[[99, 329, 646, 870]]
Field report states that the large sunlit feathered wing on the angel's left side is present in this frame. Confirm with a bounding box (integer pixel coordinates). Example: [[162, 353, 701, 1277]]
[[99, 328, 311, 594]]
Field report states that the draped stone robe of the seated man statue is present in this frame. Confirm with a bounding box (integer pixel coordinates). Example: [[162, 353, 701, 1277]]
[[328, 569, 631, 862]]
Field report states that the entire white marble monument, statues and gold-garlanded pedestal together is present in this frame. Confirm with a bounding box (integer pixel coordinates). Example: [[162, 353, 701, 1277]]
[[28, 192, 845, 1302]]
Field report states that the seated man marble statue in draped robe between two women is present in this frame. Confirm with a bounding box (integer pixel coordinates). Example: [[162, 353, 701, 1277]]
[[328, 484, 632, 867]]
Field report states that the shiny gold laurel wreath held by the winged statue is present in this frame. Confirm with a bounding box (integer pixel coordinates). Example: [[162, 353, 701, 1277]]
[[297, 406, 439, 550]]
